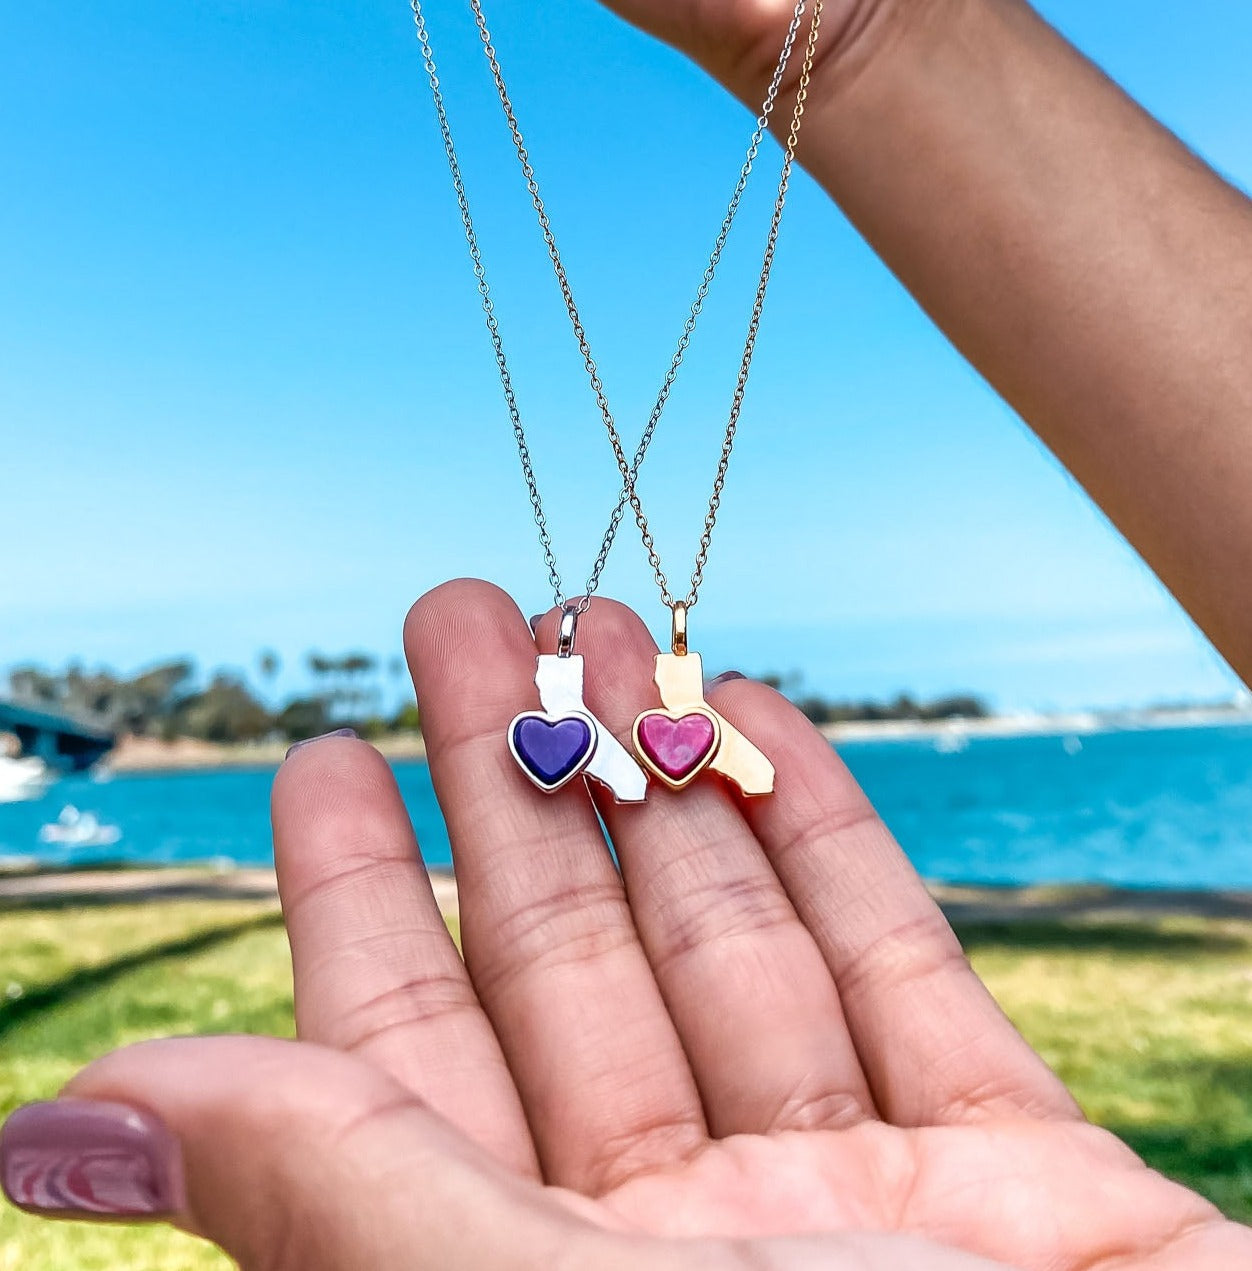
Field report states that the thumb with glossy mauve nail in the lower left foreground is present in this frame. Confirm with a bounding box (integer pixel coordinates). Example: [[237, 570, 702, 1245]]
[[0, 1037, 587, 1271]]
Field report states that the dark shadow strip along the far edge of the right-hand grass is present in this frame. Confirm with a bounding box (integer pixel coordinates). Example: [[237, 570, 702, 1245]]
[[949, 914, 1249, 953]]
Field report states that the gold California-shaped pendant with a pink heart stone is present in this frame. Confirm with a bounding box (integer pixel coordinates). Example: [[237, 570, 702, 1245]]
[[634, 601, 774, 796]]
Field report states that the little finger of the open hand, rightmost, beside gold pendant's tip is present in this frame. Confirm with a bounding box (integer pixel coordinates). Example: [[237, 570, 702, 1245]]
[[716, 680, 1078, 1126]]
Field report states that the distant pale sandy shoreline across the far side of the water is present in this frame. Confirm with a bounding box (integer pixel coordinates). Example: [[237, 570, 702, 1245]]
[[95, 707, 1252, 775]]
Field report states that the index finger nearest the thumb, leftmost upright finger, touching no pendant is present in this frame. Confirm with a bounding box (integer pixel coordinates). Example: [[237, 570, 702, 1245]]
[[273, 737, 539, 1174]]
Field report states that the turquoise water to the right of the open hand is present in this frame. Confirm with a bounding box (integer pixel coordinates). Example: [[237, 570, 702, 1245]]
[[840, 726, 1252, 888]]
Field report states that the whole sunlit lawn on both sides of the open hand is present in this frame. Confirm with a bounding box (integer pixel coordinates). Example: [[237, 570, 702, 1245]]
[[0, 901, 1252, 1271]]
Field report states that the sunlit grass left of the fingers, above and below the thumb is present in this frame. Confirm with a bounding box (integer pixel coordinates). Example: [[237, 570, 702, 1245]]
[[0, 901, 292, 1271]]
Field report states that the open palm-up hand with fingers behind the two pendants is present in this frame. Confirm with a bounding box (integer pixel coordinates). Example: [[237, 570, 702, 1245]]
[[4, 582, 1252, 1271]]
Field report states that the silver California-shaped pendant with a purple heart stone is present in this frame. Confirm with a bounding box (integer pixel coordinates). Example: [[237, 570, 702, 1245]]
[[508, 609, 648, 803]]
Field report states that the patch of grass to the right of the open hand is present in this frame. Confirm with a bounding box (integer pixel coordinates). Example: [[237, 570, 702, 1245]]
[[961, 918, 1252, 1223]]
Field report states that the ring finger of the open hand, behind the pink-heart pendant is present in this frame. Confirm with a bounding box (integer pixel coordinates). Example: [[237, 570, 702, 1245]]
[[540, 600, 873, 1138]]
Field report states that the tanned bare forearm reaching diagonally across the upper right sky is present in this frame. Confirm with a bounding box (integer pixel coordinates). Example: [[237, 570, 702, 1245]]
[[772, 0, 1252, 679]]
